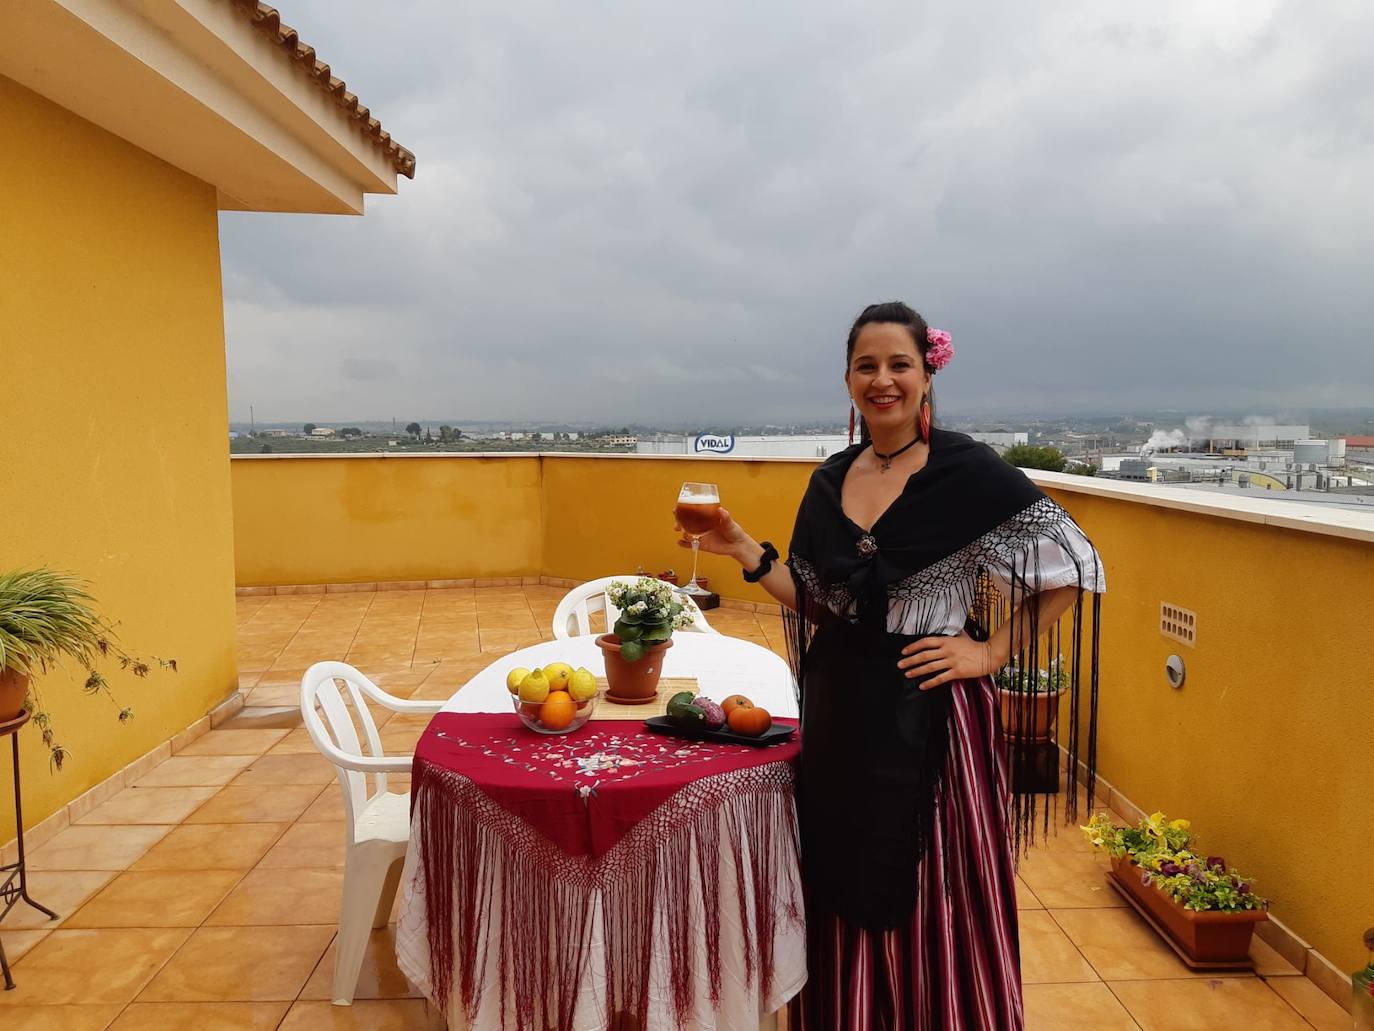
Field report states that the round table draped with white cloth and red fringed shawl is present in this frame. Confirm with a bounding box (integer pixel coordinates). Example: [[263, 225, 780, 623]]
[[396, 632, 807, 1031]]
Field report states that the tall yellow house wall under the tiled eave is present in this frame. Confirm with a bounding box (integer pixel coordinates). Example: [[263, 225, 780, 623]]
[[0, 77, 236, 839]]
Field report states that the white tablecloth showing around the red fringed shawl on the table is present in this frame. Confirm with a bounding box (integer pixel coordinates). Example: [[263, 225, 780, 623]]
[[396, 632, 807, 1031]]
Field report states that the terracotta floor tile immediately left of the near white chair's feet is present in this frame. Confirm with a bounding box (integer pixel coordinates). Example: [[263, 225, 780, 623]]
[[139, 925, 334, 1002]]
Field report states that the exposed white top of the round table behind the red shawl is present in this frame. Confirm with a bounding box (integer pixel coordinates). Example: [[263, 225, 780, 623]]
[[441, 632, 797, 719]]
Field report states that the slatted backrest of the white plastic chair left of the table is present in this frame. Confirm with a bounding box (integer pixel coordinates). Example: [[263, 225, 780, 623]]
[[301, 663, 398, 841]]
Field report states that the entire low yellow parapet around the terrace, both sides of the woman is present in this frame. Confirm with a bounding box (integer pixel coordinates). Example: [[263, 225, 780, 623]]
[[232, 455, 1374, 969]]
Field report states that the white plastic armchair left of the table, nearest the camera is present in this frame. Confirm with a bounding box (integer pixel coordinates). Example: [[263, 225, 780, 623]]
[[301, 663, 444, 1006]]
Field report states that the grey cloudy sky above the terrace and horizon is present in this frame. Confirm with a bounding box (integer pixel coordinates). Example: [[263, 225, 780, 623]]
[[221, 0, 1374, 425]]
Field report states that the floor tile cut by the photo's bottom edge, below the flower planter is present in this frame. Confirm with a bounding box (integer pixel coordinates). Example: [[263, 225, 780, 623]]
[[1110, 977, 1309, 1031]]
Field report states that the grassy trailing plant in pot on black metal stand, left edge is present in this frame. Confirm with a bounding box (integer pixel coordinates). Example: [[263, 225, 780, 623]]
[[0, 569, 176, 770]]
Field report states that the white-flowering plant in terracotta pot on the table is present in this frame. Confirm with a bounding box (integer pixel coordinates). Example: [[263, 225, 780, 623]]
[[596, 576, 692, 705]]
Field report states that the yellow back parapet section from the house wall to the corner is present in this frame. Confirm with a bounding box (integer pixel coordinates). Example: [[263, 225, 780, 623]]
[[232, 455, 543, 586]]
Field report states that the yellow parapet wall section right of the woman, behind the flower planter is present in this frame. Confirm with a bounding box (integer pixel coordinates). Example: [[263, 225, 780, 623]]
[[1050, 489, 1374, 971]]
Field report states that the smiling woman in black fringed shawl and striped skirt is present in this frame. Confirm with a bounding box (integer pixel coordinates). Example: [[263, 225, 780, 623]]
[[687, 302, 1106, 1031]]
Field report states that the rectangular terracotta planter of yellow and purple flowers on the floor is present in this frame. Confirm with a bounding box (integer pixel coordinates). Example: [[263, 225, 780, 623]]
[[1083, 812, 1270, 968]]
